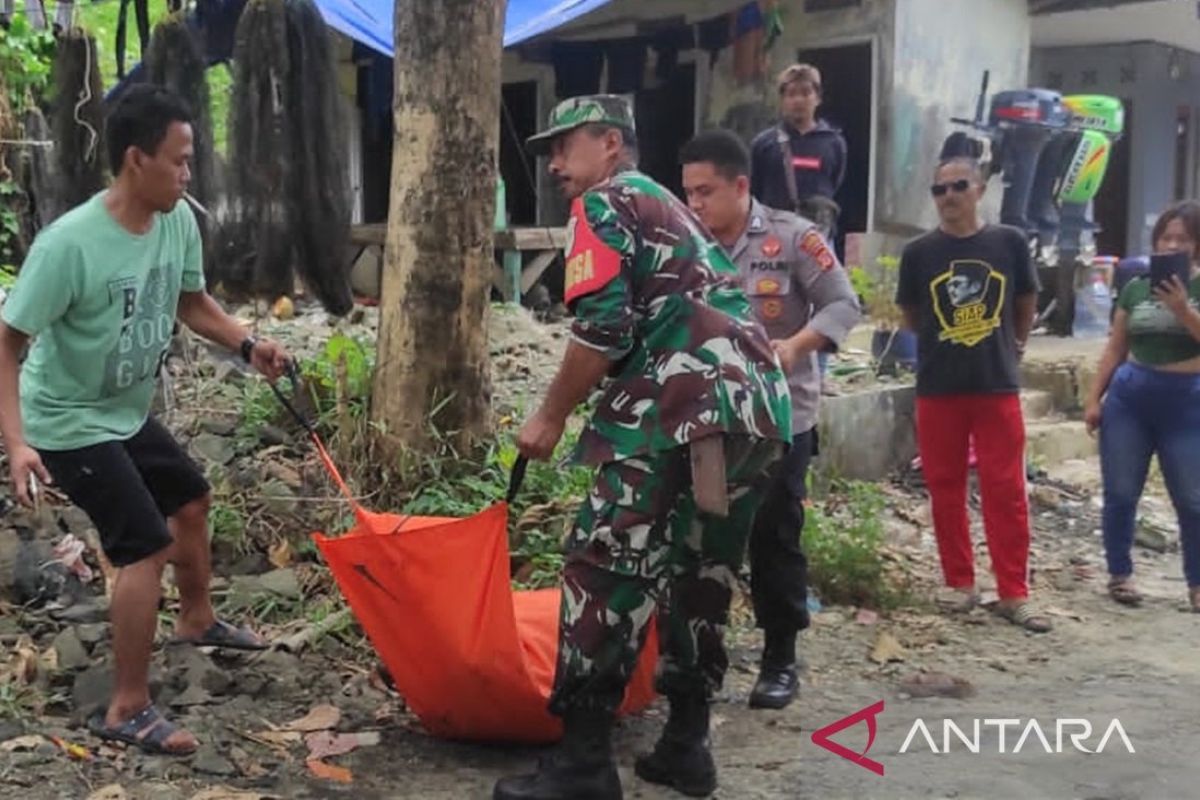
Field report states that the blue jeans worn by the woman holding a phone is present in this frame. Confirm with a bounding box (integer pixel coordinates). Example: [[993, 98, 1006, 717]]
[[1100, 363, 1200, 587]]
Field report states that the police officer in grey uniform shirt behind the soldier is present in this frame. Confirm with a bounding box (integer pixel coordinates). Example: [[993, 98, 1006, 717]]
[[679, 131, 862, 709]]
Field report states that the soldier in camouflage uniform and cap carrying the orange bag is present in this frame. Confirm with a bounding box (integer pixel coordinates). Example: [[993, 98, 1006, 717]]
[[494, 96, 791, 800]]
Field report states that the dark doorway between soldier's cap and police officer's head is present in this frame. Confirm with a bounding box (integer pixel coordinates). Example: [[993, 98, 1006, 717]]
[[634, 64, 696, 197]]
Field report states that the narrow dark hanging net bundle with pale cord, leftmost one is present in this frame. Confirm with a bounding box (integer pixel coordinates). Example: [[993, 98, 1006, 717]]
[[50, 28, 106, 210]]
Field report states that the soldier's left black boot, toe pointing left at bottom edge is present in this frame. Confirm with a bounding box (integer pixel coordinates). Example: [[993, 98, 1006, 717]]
[[492, 711, 622, 800]]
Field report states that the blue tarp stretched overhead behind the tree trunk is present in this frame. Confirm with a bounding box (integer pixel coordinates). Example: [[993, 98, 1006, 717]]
[[316, 0, 610, 56]]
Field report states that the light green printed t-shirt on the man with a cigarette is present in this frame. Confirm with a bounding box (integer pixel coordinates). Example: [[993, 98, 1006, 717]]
[[0, 192, 204, 450]]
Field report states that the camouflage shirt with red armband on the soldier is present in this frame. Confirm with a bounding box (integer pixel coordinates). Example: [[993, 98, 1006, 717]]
[[565, 170, 791, 464]]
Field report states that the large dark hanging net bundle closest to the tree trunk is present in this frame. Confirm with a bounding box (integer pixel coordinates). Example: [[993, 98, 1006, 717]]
[[217, 0, 352, 314]]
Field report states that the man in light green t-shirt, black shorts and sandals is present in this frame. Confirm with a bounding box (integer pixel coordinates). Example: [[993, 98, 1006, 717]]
[[0, 85, 288, 754]]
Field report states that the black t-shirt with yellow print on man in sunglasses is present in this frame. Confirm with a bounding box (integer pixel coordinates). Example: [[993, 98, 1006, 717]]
[[896, 225, 1039, 396]]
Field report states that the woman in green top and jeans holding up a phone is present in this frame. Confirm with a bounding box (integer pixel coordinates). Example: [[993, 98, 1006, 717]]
[[1085, 200, 1200, 613]]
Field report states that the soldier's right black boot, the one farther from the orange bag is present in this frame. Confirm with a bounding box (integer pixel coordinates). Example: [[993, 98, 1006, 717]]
[[634, 696, 716, 798]]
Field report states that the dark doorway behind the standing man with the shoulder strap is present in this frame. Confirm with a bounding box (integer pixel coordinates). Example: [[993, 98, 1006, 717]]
[[798, 42, 875, 253]]
